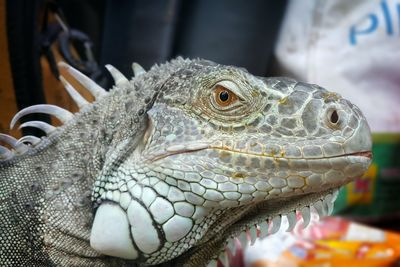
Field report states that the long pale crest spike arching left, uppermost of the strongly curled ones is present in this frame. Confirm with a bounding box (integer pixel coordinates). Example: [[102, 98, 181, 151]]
[[10, 104, 74, 129]]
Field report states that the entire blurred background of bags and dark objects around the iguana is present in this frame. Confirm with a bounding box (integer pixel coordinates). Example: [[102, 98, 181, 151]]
[[0, 0, 400, 267]]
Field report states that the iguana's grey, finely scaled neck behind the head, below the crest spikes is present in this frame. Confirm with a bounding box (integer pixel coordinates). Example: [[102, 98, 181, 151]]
[[0, 85, 148, 266]]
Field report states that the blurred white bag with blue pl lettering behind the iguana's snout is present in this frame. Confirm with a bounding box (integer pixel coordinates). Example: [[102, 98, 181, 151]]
[[276, 0, 400, 132]]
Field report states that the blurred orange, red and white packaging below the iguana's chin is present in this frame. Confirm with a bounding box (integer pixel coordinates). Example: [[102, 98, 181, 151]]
[[245, 217, 400, 267]]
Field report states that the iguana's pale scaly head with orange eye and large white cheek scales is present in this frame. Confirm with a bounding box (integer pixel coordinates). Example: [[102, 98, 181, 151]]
[[91, 60, 371, 266]]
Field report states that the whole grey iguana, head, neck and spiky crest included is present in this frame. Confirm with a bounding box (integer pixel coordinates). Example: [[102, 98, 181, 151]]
[[0, 58, 371, 266]]
